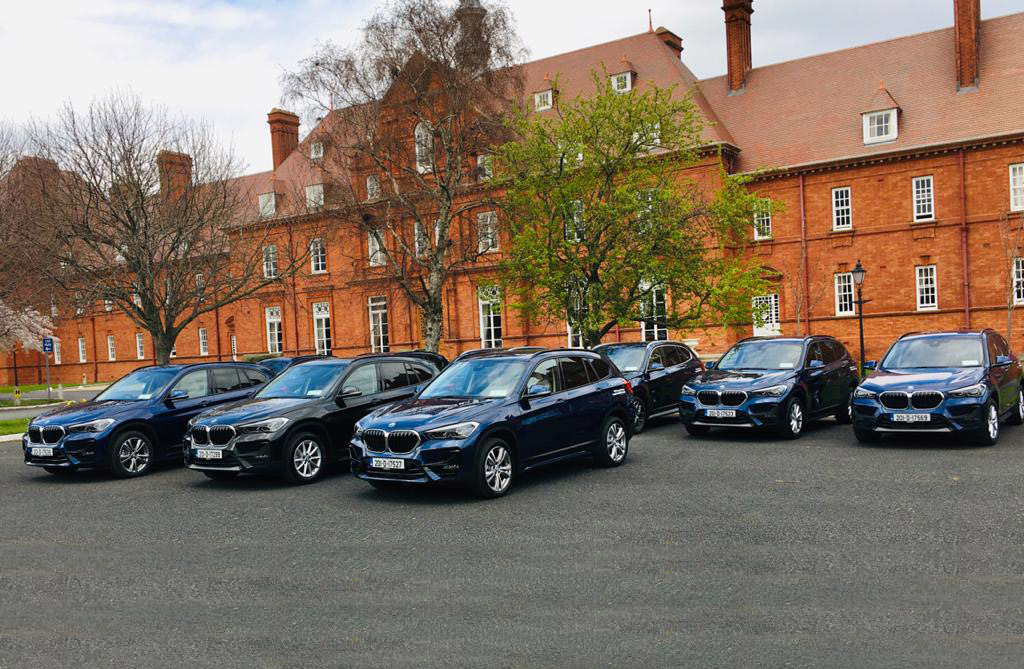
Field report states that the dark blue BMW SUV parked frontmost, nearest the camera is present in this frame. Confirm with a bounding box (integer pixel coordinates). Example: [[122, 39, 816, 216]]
[[351, 350, 632, 498]]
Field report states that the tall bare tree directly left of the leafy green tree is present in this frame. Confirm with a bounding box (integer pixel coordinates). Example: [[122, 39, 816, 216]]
[[283, 0, 524, 350]]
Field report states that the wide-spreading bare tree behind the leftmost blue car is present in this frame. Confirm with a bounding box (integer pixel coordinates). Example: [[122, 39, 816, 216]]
[[22, 94, 308, 363]]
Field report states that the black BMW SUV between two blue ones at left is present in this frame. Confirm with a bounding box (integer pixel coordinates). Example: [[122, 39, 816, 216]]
[[184, 353, 436, 484]]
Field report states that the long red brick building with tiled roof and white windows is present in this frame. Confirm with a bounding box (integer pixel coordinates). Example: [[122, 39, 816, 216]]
[[0, 0, 1024, 383]]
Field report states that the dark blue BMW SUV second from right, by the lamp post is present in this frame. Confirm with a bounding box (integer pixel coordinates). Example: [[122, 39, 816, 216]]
[[679, 335, 858, 438]]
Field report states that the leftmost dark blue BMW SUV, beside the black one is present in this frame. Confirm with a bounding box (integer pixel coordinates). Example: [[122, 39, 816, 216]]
[[22, 363, 270, 478]]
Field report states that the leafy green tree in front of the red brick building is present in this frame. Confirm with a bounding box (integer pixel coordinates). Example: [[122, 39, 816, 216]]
[[497, 73, 765, 346]]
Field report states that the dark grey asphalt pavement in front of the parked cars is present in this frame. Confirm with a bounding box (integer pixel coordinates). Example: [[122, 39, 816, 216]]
[[0, 419, 1024, 669]]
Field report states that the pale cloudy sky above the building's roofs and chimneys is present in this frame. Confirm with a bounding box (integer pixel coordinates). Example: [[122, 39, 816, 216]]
[[0, 0, 1024, 171]]
